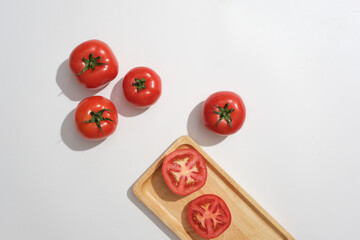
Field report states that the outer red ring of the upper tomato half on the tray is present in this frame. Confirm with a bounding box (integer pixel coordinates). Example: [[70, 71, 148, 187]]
[[162, 149, 207, 196]]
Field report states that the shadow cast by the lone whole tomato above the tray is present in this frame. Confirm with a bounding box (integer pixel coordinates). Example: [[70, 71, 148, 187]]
[[187, 101, 226, 146]]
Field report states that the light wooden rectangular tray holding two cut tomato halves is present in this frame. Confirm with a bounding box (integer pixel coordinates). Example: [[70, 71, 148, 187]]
[[133, 136, 294, 240]]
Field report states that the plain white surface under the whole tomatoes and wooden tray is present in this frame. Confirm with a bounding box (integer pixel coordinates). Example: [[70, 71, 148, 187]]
[[0, 0, 360, 240]]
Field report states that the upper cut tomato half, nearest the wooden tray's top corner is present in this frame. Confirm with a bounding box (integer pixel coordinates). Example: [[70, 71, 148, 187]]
[[162, 149, 207, 196]]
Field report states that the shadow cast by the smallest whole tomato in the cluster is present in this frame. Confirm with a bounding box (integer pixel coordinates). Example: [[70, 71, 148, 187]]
[[110, 78, 149, 117]]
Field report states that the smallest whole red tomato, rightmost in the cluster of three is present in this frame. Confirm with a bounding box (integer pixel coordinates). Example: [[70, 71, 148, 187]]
[[123, 67, 161, 108]]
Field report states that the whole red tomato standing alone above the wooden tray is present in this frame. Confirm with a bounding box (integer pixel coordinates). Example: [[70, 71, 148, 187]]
[[202, 91, 246, 135]]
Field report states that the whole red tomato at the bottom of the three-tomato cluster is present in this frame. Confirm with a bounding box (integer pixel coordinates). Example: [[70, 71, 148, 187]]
[[75, 96, 118, 140]]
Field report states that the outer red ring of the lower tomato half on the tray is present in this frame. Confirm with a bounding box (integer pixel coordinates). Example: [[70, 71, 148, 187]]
[[187, 194, 231, 239]]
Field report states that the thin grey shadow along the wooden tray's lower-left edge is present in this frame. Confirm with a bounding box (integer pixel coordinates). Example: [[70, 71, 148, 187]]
[[127, 184, 180, 240]]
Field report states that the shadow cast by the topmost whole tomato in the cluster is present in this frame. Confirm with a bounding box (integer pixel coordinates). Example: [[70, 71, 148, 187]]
[[56, 59, 102, 101]]
